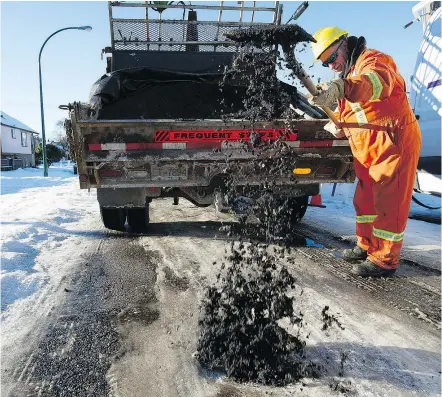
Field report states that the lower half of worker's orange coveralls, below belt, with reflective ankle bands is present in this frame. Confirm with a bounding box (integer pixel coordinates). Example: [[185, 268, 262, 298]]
[[348, 116, 421, 269]]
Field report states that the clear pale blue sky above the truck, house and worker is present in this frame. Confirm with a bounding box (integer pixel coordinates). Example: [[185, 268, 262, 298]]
[[1, 1, 422, 138]]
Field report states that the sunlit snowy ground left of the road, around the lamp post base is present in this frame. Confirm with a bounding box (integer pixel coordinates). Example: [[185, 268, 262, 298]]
[[1, 167, 98, 320]]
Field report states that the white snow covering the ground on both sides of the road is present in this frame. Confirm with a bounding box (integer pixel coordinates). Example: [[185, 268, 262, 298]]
[[0, 167, 441, 318]]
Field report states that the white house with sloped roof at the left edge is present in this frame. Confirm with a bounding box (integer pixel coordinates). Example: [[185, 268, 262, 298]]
[[0, 111, 39, 170]]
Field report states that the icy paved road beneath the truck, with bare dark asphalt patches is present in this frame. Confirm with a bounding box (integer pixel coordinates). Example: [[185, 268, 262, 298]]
[[2, 200, 441, 397]]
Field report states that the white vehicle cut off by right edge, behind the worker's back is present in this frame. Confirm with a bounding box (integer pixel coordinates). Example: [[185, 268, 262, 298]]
[[405, 1, 442, 197]]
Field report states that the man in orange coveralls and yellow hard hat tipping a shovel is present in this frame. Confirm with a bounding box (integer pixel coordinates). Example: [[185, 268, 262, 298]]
[[310, 27, 421, 277]]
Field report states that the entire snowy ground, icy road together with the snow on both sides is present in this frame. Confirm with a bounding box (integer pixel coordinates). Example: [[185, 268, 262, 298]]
[[1, 168, 441, 397]]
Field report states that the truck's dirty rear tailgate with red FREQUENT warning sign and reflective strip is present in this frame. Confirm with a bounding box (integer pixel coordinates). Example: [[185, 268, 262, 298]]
[[68, 104, 354, 189]]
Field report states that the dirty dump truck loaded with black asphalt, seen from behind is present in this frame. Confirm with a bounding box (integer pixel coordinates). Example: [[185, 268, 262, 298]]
[[63, 1, 355, 232]]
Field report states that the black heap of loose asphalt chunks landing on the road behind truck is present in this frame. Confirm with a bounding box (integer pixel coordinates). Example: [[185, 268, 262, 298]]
[[198, 242, 320, 386]]
